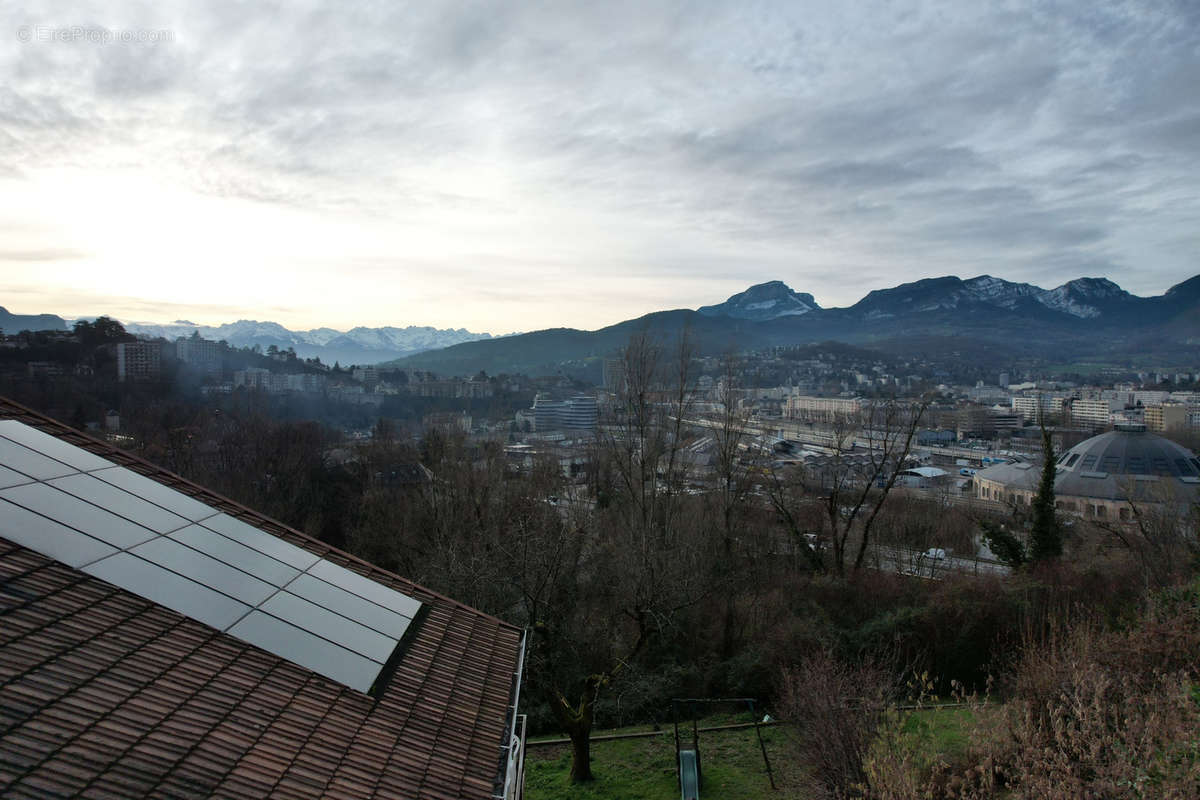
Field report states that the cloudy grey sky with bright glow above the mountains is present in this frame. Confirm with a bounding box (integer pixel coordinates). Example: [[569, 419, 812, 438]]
[[0, 0, 1200, 333]]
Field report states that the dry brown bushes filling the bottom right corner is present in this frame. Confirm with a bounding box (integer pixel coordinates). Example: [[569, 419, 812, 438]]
[[866, 596, 1200, 800]]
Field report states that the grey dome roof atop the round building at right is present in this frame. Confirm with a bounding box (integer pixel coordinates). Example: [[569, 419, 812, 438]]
[[1055, 429, 1200, 499]]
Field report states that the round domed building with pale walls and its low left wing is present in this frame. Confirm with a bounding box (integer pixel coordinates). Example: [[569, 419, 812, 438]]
[[974, 426, 1200, 519]]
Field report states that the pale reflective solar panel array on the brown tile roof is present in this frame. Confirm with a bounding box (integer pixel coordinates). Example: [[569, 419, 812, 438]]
[[0, 420, 421, 692]]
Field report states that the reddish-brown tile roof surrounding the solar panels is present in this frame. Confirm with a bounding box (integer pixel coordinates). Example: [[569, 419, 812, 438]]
[[0, 398, 522, 799]]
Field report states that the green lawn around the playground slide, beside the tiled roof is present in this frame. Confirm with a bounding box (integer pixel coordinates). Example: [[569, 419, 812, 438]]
[[524, 728, 798, 800]]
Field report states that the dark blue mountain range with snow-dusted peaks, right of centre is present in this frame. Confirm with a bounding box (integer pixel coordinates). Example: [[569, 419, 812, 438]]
[[395, 275, 1200, 374]]
